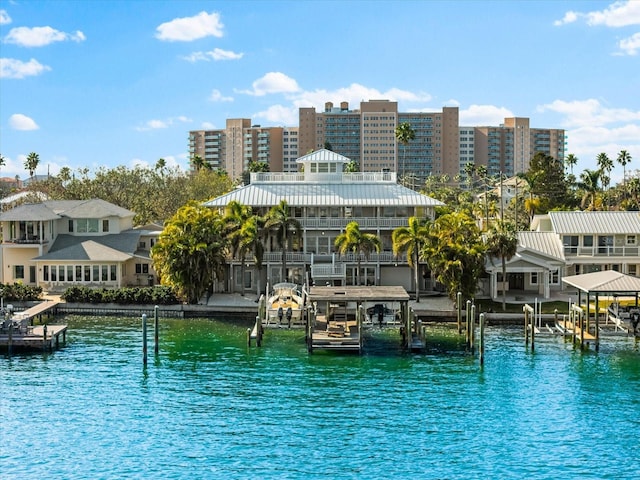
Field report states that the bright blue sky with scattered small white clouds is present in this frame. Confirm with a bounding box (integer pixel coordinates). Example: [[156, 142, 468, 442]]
[[0, 0, 640, 181]]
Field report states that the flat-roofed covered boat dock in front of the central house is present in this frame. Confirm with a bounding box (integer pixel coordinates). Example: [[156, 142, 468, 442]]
[[307, 286, 419, 352]]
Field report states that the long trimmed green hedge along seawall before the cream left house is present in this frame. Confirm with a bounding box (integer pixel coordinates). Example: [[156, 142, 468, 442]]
[[62, 286, 180, 305]]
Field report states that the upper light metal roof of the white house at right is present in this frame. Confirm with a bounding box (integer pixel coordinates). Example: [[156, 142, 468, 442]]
[[549, 211, 640, 235]]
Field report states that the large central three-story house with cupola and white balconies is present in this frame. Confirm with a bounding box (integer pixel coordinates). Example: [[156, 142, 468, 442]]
[[205, 149, 443, 291]]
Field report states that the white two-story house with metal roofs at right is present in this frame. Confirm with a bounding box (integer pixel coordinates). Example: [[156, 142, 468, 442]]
[[485, 211, 640, 298]]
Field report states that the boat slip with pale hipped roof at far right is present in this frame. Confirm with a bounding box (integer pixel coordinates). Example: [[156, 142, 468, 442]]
[[556, 270, 640, 350]]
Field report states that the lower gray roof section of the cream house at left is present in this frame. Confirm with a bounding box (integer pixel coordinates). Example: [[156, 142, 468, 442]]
[[34, 231, 140, 262]]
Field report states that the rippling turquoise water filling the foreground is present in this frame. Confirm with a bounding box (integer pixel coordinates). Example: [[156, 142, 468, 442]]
[[0, 317, 640, 479]]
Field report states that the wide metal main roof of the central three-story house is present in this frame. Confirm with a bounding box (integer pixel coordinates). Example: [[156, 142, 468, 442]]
[[205, 182, 444, 207]]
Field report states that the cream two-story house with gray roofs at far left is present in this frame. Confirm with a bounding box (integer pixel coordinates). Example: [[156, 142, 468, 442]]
[[0, 199, 161, 291]]
